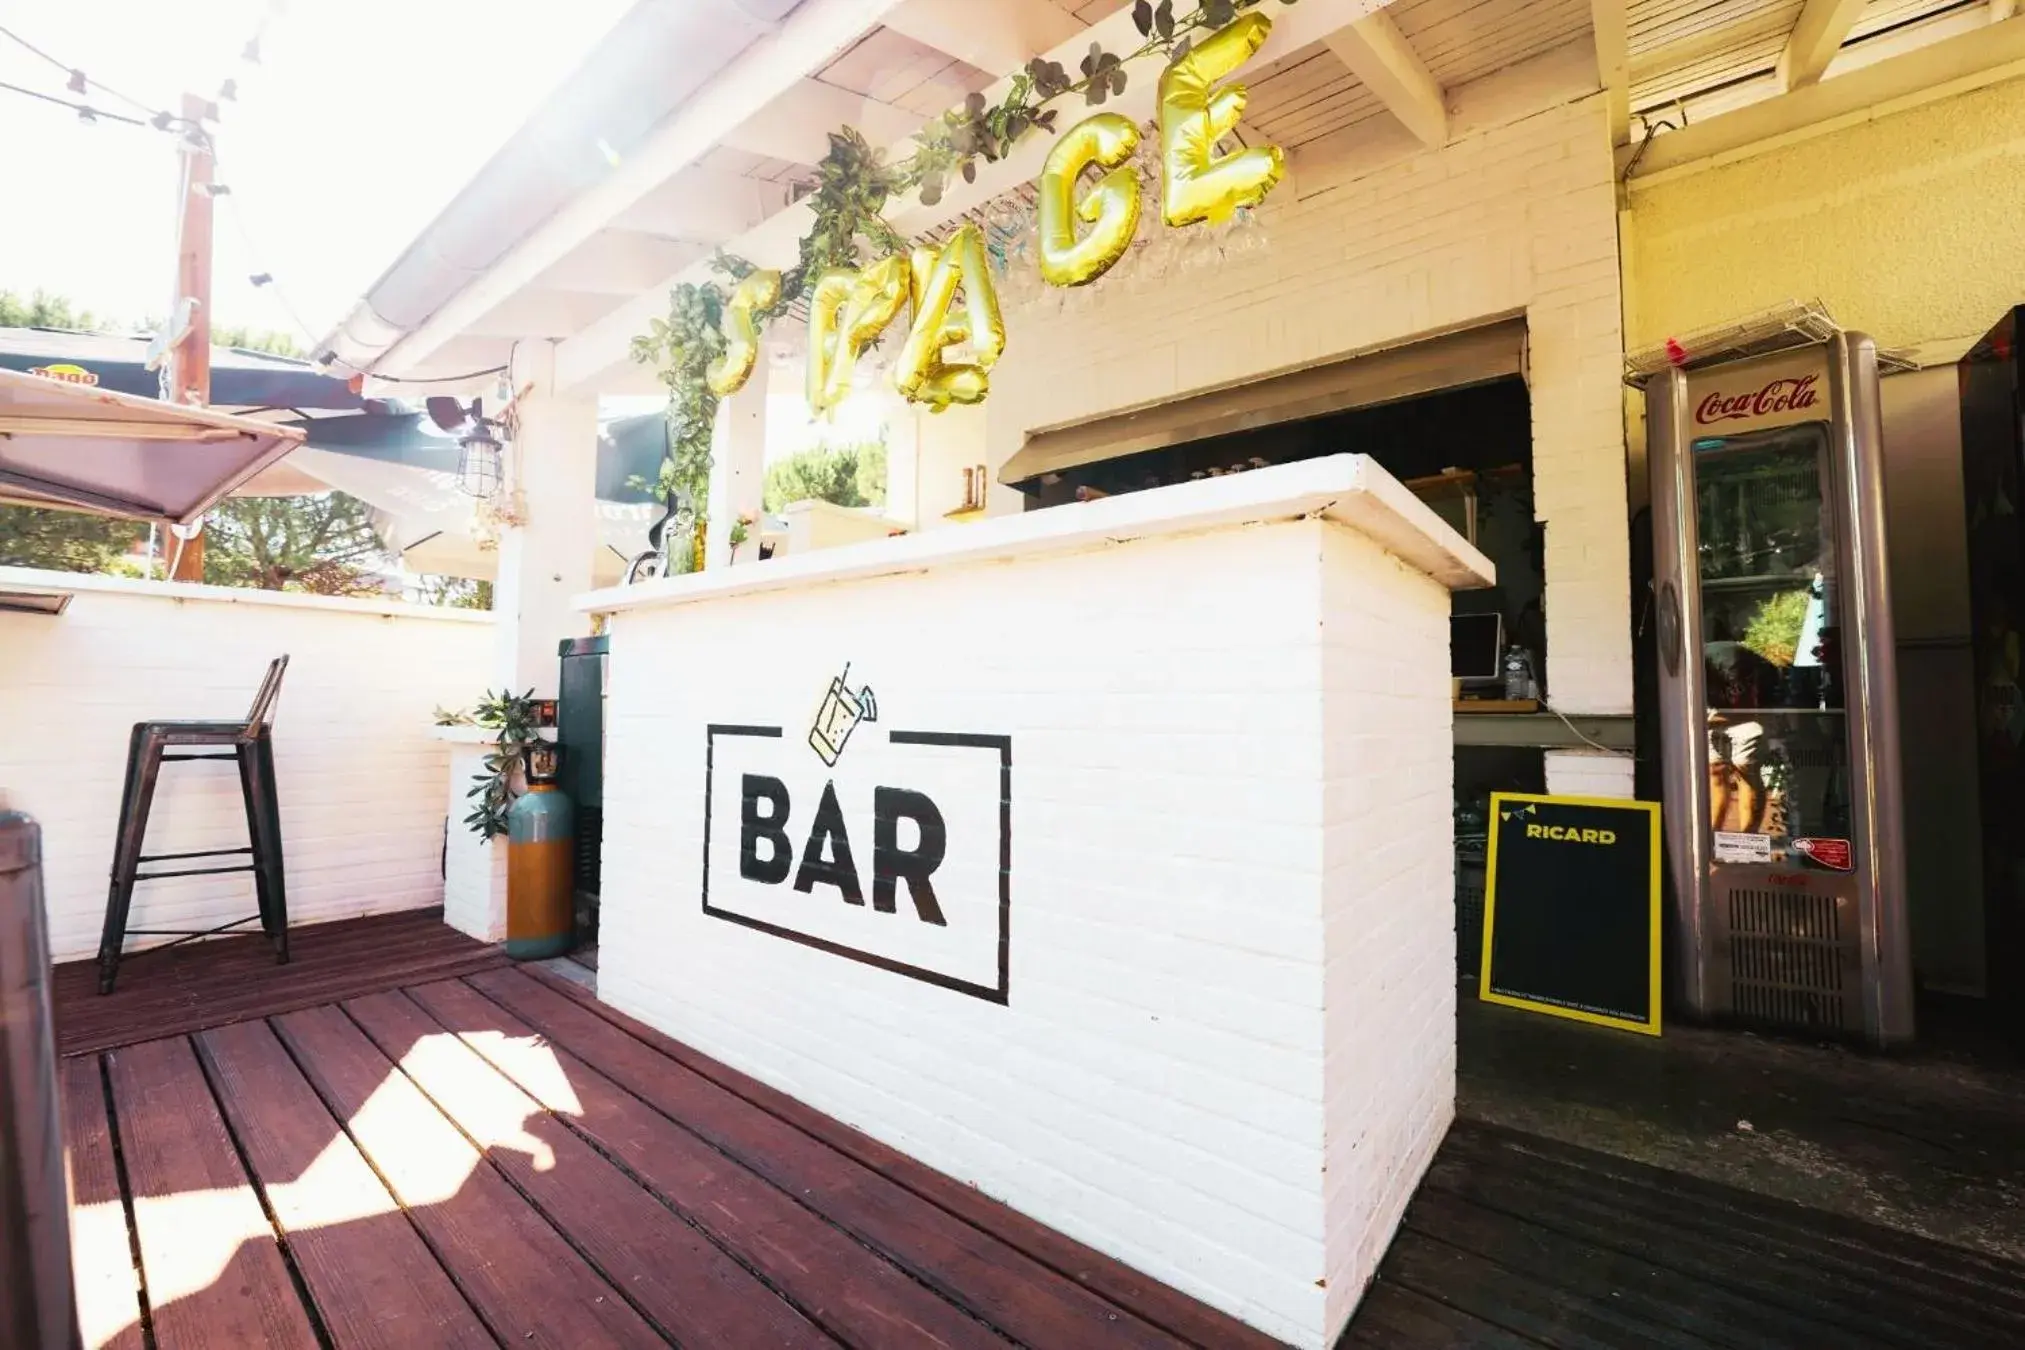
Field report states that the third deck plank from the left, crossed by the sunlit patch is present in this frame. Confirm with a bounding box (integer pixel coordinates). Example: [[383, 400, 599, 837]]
[[196, 1022, 494, 1350]]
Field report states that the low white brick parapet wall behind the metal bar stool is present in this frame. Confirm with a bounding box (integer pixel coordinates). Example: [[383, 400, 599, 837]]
[[0, 569, 492, 961]]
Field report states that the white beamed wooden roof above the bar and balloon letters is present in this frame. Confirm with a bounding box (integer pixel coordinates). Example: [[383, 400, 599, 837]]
[[330, 0, 2025, 393]]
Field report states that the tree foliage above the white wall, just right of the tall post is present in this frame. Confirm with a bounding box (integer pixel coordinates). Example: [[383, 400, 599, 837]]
[[205, 492, 391, 595]]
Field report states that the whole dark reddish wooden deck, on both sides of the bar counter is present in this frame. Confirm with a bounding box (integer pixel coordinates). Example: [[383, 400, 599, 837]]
[[57, 915, 2025, 1350]]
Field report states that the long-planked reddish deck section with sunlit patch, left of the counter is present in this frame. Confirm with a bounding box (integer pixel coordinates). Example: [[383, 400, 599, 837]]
[[63, 955, 1274, 1350]]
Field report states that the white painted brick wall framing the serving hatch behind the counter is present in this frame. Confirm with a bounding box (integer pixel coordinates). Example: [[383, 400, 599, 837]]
[[986, 96, 1632, 732]]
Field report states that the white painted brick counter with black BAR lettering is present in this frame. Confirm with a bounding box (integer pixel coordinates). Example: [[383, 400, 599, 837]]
[[579, 455, 1492, 1346]]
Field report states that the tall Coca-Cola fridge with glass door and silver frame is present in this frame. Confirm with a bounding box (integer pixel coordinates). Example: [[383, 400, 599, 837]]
[[1644, 334, 1914, 1046]]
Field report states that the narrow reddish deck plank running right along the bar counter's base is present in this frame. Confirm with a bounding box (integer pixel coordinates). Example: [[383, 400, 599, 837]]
[[527, 969, 1280, 1350]]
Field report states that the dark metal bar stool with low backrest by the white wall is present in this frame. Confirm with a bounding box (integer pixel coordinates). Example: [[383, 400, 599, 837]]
[[99, 656, 288, 994]]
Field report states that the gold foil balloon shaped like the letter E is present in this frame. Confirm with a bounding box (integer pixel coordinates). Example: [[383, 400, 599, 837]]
[[1160, 14, 1286, 227]]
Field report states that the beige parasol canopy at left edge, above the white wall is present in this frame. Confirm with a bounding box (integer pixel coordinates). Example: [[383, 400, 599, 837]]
[[0, 370, 302, 524]]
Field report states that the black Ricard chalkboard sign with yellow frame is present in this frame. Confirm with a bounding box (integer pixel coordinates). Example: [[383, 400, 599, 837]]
[[1476, 791, 1661, 1036]]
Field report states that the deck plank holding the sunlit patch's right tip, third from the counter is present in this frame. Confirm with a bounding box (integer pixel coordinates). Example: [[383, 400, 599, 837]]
[[407, 982, 1004, 1350]]
